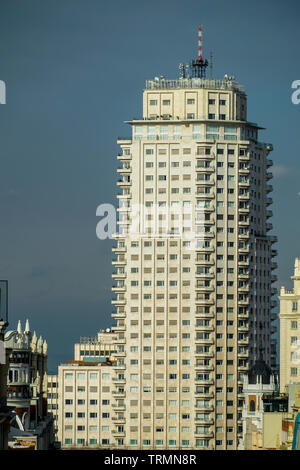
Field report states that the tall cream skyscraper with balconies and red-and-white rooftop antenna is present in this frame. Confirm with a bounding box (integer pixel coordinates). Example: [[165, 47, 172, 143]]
[[112, 28, 276, 450]]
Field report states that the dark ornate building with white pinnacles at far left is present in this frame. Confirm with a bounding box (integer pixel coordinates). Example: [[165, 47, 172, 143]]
[[5, 321, 54, 450]]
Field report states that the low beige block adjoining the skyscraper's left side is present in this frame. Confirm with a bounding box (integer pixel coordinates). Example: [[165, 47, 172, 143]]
[[57, 361, 114, 448]]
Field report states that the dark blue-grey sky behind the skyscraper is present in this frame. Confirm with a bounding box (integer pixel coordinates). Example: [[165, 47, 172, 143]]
[[0, 0, 300, 372]]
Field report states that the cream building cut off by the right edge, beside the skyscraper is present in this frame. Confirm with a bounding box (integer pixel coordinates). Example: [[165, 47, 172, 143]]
[[279, 258, 300, 392]]
